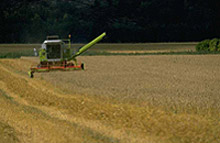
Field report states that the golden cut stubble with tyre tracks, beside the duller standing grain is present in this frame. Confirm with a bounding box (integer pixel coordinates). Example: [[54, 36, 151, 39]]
[[0, 59, 220, 143]]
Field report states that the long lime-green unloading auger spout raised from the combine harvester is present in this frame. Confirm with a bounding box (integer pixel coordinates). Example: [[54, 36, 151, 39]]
[[71, 32, 106, 59]]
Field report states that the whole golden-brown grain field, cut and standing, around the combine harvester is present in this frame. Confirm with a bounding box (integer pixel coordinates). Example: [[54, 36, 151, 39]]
[[0, 55, 220, 143]]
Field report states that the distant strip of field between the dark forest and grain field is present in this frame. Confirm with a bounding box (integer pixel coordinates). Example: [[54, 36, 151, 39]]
[[0, 43, 196, 58]]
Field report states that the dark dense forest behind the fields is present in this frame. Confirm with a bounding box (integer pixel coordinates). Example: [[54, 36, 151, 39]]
[[0, 0, 217, 43]]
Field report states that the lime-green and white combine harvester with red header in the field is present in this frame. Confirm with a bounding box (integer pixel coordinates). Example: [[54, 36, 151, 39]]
[[28, 33, 106, 78]]
